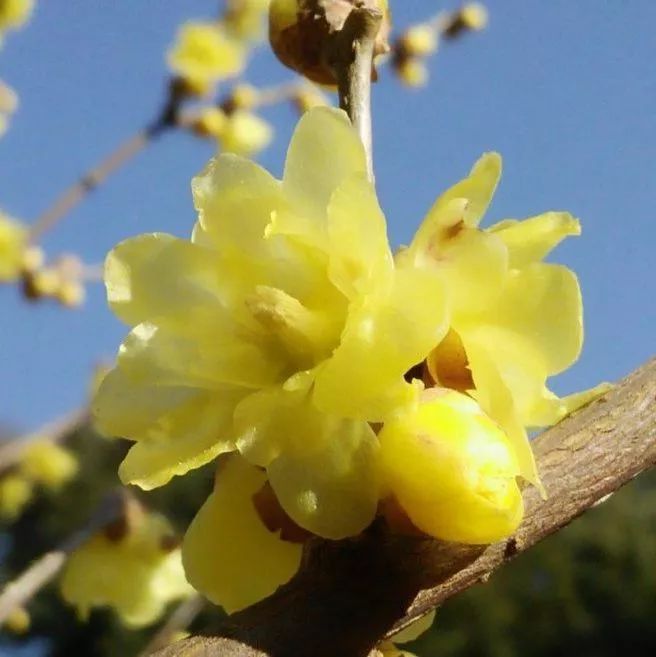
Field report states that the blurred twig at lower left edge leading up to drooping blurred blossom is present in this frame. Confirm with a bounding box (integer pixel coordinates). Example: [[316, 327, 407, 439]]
[[0, 490, 125, 626]]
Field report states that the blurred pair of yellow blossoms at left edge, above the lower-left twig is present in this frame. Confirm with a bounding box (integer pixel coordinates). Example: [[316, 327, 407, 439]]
[[0, 438, 78, 521]]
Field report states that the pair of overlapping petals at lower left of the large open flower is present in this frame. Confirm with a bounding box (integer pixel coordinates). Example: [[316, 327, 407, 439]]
[[93, 369, 243, 489]]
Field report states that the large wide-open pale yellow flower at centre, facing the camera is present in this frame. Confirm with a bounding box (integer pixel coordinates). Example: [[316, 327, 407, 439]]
[[94, 108, 448, 538]]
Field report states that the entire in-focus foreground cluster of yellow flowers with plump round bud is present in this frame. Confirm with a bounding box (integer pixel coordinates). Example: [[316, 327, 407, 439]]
[[93, 107, 597, 611]]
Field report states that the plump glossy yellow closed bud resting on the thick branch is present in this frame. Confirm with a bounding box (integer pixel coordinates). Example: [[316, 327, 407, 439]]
[[379, 388, 524, 544]]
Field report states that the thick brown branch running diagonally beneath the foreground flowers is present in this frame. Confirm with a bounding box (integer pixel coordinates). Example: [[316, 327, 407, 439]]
[[151, 359, 656, 657]]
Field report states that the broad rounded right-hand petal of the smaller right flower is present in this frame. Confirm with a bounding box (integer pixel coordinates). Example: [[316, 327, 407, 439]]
[[480, 263, 583, 375]]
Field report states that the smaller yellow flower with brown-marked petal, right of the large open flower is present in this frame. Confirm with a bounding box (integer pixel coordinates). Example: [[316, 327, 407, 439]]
[[397, 153, 606, 486]]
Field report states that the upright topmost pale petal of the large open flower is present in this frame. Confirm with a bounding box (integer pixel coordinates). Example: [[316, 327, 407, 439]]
[[283, 107, 367, 220]]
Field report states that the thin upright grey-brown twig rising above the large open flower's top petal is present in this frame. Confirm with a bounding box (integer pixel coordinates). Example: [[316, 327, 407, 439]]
[[328, 6, 383, 181]]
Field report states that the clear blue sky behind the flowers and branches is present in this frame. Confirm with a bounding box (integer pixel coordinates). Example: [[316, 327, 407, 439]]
[[0, 0, 656, 430]]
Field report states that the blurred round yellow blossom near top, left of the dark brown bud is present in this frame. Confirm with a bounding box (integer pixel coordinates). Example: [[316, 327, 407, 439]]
[[168, 22, 246, 95]]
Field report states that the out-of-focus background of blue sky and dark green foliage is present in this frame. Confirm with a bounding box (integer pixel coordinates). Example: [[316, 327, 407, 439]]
[[0, 0, 656, 657]]
